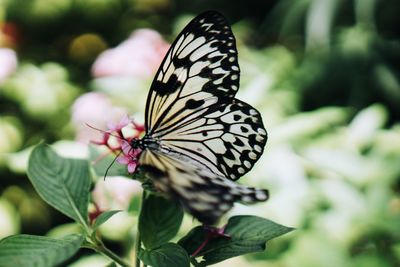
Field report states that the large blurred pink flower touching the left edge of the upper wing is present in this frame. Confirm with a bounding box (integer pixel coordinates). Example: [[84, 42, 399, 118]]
[[92, 29, 170, 78]]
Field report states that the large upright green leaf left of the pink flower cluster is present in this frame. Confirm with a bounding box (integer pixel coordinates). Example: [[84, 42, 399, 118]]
[[28, 144, 90, 225]]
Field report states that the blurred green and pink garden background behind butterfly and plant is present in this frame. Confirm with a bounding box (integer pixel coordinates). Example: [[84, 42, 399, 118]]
[[0, 0, 400, 267]]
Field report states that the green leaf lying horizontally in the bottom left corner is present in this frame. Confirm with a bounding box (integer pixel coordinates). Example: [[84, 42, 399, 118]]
[[0, 234, 84, 267]]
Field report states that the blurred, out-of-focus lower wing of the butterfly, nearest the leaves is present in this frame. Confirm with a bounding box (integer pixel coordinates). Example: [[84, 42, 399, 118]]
[[139, 150, 268, 225]]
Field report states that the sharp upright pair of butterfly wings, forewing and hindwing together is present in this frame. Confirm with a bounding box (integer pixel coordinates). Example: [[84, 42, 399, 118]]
[[145, 11, 267, 180]]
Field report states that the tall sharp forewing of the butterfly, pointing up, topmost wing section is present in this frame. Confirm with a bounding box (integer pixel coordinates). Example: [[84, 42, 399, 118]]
[[145, 11, 239, 138]]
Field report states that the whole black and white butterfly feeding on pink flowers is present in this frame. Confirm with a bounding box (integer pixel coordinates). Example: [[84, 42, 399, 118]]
[[130, 11, 268, 224]]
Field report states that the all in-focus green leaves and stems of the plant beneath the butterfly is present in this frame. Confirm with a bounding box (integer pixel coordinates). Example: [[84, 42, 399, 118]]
[[0, 144, 291, 267]]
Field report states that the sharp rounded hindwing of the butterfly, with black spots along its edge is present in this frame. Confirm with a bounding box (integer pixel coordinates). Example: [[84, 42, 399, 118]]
[[160, 99, 267, 180]]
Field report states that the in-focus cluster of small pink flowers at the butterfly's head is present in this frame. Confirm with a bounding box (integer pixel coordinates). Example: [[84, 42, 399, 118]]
[[92, 116, 145, 173]]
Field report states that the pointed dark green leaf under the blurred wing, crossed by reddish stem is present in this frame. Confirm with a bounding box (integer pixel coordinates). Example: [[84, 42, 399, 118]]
[[178, 216, 293, 266]]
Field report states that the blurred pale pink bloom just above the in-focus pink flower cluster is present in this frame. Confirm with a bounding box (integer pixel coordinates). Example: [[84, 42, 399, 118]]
[[72, 93, 127, 143]]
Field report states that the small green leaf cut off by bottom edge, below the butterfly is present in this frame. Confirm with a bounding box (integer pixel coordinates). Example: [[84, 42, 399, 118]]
[[139, 243, 190, 267]]
